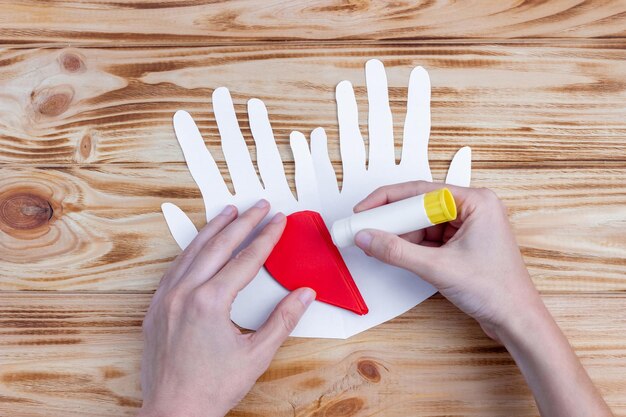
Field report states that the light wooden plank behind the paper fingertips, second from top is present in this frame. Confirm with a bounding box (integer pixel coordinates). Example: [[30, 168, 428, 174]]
[[0, 40, 626, 165]]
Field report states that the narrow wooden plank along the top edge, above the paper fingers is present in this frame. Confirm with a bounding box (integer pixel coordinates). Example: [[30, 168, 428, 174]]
[[0, 0, 626, 45]]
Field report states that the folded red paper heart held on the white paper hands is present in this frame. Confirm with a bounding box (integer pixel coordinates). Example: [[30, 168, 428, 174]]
[[265, 211, 368, 315]]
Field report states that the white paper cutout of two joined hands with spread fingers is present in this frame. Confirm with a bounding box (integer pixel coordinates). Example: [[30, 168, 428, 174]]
[[162, 60, 471, 338]]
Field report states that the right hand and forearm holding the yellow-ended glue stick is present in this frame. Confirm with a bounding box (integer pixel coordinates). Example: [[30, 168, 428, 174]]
[[355, 181, 613, 417]]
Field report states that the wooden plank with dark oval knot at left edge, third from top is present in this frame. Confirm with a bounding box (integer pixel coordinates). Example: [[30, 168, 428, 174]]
[[0, 163, 626, 292]]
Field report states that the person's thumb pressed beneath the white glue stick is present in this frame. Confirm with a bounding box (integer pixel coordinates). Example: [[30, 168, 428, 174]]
[[355, 229, 440, 281]]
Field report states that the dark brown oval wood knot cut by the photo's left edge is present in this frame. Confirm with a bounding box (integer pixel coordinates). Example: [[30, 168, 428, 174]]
[[0, 193, 54, 230]]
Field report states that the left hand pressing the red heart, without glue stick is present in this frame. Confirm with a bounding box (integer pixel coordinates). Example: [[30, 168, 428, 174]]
[[139, 200, 315, 417]]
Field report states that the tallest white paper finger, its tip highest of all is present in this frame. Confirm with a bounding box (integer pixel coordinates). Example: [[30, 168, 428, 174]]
[[365, 59, 396, 170]]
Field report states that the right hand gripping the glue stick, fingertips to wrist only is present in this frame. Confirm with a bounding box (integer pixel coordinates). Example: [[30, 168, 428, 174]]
[[354, 181, 544, 340]]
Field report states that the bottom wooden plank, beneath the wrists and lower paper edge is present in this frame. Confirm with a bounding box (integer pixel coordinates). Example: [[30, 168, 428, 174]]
[[0, 293, 626, 417]]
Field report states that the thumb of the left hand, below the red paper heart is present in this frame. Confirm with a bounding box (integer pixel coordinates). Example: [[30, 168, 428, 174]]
[[255, 288, 315, 355]]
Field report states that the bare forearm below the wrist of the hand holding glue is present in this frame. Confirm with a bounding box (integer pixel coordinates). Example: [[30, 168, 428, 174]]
[[498, 300, 613, 417]]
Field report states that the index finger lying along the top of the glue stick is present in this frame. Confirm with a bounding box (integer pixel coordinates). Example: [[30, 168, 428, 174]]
[[354, 181, 471, 213]]
